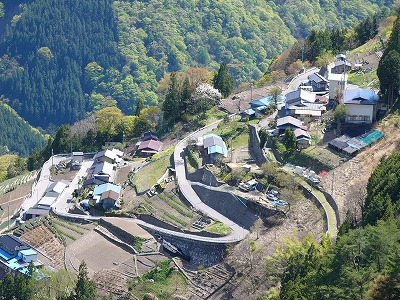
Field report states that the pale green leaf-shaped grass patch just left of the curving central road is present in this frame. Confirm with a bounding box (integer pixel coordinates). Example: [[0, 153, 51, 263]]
[[132, 148, 174, 193]]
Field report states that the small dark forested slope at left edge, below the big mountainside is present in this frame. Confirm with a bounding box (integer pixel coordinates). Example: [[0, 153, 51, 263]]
[[0, 103, 46, 156]]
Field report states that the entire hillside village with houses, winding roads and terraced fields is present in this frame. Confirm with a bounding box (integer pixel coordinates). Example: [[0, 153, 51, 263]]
[[0, 48, 388, 299]]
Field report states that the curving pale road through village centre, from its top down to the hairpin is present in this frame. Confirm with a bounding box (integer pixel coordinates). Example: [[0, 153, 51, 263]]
[[174, 120, 249, 243]]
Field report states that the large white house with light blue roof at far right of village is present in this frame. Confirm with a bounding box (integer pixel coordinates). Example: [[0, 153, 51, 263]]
[[344, 88, 379, 124]]
